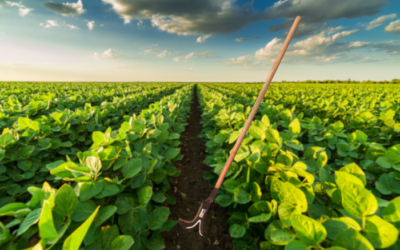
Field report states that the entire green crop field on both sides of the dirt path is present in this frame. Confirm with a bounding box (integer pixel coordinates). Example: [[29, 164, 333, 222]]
[[0, 83, 400, 250]]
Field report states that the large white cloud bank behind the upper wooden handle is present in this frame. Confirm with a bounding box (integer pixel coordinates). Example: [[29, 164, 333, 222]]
[[224, 26, 400, 67]]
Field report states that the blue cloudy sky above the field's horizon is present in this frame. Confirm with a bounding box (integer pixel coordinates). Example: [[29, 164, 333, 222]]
[[0, 0, 400, 82]]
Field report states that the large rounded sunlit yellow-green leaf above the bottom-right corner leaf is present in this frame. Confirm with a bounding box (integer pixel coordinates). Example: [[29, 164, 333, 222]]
[[341, 182, 378, 218]]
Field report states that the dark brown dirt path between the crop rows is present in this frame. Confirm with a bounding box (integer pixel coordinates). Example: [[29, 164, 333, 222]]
[[163, 87, 233, 250]]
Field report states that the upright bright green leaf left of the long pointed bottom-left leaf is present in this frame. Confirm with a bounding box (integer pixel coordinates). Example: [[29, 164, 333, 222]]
[[39, 200, 58, 240]]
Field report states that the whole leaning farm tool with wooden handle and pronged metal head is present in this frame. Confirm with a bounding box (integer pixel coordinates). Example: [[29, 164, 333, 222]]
[[179, 16, 301, 236]]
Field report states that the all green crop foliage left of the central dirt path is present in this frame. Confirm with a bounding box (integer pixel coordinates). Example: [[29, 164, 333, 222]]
[[0, 83, 194, 250]]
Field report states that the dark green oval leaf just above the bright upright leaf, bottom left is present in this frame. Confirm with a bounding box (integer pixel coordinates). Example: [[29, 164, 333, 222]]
[[54, 184, 79, 216]]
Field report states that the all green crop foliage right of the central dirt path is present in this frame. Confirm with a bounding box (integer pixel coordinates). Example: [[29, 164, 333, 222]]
[[198, 85, 400, 250]]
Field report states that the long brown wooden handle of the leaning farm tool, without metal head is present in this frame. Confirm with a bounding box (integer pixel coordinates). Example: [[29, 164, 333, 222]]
[[215, 16, 301, 189]]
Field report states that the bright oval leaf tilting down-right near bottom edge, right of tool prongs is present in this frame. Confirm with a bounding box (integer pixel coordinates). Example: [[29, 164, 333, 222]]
[[292, 214, 327, 246]]
